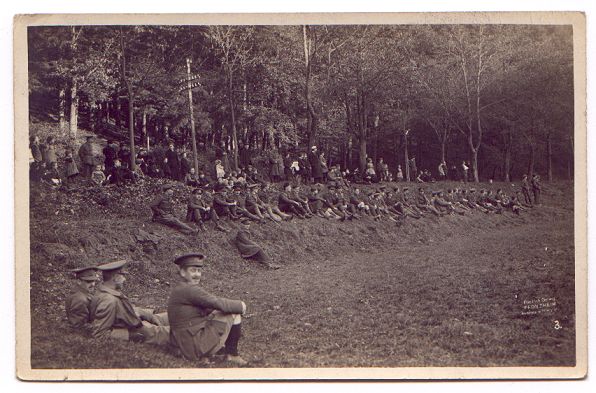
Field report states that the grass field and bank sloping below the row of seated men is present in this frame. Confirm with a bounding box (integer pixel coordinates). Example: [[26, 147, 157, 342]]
[[31, 179, 575, 368]]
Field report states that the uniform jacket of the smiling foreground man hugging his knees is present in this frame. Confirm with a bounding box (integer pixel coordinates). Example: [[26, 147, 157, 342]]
[[168, 283, 243, 360]]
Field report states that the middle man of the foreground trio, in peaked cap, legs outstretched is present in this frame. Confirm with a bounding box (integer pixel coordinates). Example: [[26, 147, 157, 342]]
[[89, 260, 170, 345]]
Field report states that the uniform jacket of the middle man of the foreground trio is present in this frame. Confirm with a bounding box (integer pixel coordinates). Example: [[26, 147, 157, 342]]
[[89, 284, 142, 337]]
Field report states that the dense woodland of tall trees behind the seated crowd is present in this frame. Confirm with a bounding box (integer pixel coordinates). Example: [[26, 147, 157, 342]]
[[28, 25, 574, 181]]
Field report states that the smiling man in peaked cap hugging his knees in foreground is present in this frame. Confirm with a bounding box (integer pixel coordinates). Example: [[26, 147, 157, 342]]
[[168, 253, 247, 366]]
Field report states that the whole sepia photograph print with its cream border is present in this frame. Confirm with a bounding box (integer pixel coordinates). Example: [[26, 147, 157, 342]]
[[15, 12, 587, 380]]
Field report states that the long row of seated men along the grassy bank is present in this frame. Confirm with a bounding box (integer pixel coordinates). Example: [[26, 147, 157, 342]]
[[151, 183, 527, 234]]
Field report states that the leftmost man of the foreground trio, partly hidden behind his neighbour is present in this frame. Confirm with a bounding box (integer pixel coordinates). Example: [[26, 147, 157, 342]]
[[65, 266, 97, 328]]
